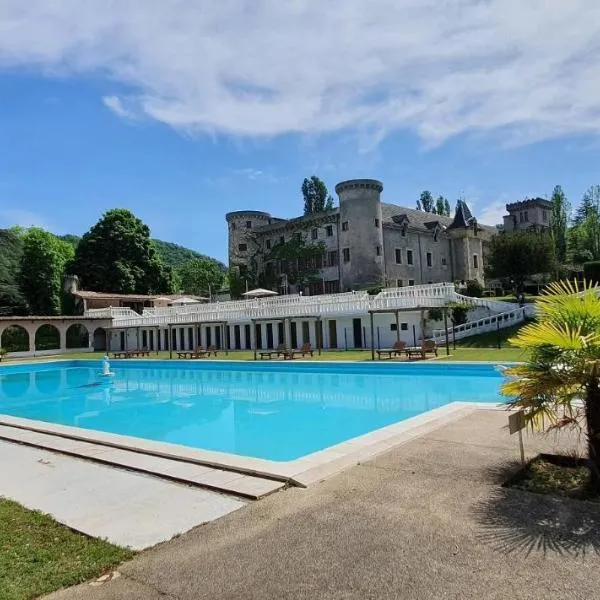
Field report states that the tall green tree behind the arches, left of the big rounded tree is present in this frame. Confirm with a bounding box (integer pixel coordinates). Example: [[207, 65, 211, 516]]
[[19, 228, 74, 315]]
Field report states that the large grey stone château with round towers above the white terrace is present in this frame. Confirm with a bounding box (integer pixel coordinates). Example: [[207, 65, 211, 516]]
[[226, 179, 496, 294]]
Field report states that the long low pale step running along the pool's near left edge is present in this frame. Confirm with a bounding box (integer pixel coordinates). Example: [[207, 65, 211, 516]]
[[0, 425, 286, 500]]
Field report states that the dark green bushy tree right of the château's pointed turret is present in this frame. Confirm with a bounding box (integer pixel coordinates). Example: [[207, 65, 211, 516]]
[[486, 231, 555, 290]]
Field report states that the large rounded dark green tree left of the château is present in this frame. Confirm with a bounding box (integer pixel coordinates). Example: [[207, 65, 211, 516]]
[[73, 208, 173, 294]]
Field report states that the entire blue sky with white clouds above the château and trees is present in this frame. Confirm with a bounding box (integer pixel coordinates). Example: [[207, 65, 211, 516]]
[[0, 0, 600, 260]]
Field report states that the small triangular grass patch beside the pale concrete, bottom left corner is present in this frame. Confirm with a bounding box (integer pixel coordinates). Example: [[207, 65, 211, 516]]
[[0, 498, 134, 600]]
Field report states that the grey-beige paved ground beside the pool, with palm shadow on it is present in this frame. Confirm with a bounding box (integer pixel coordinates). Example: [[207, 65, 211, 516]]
[[48, 410, 600, 600]]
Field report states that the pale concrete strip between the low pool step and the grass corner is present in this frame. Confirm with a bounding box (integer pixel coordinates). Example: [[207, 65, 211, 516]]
[[0, 441, 244, 548]]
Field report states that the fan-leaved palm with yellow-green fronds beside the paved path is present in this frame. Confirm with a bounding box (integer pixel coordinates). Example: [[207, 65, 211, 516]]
[[502, 281, 600, 493]]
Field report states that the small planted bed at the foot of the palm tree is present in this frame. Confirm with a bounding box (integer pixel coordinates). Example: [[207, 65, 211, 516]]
[[505, 454, 600, 502]]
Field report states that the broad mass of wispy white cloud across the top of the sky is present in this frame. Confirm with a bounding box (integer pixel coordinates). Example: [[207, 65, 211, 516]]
[[0, 0, 600, 148]]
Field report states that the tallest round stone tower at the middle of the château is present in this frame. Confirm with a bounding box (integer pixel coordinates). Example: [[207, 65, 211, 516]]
[[335, 179, 385, 291]]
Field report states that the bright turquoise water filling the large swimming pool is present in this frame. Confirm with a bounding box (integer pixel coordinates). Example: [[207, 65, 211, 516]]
[[0, 360, 502, 461]]
